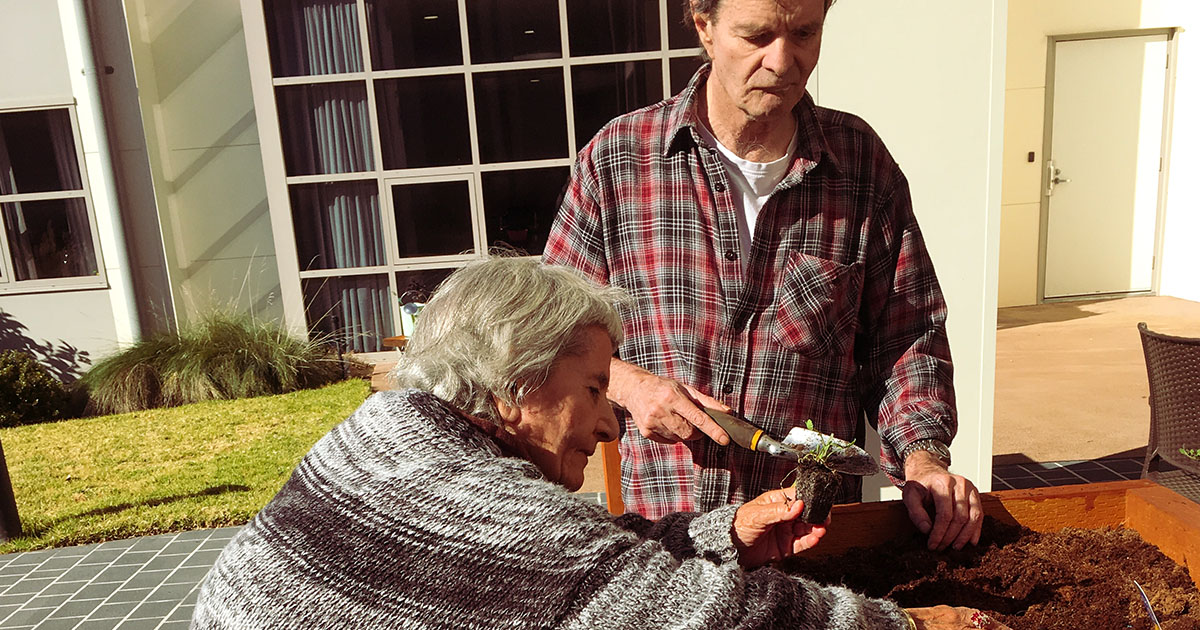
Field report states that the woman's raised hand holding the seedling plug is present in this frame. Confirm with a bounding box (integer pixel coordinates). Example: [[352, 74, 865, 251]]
[[733, 488, 829, 569]]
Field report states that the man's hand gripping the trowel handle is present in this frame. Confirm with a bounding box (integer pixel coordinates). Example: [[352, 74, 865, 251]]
[[608, 359, 730, 446]]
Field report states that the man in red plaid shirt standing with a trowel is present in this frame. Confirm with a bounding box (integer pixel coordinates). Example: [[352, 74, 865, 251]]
[[544, 0, 982, 548]]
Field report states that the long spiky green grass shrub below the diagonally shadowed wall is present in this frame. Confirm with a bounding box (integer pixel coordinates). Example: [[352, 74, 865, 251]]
[[80, 312, 343, 414]]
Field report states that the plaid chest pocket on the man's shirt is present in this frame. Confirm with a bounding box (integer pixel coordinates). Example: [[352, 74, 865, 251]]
[[772, 252, 863, 359]]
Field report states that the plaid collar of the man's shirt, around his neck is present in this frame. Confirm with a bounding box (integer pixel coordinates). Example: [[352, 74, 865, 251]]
[[666, 64, 840, 175]]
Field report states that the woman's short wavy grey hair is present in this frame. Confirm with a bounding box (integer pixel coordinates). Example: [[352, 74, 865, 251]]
[[391, 257, 628, 424]]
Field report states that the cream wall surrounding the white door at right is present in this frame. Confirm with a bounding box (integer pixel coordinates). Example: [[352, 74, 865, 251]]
[[998, 0, 1200, 306]]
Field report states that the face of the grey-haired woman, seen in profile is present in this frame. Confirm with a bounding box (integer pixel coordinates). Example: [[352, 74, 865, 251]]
[[502, 326, 618, 492]]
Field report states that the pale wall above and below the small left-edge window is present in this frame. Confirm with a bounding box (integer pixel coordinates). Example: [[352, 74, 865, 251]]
[[0, 0, 118, 380]]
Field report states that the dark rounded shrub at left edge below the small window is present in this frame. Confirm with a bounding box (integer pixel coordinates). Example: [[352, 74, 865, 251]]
[[0, 350, 71, 426]]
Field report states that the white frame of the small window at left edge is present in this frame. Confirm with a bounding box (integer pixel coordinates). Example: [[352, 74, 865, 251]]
[[0, 102, 108, 295]]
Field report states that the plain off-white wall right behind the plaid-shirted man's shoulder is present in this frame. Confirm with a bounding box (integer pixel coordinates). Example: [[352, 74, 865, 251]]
[[817, 0, 1008, 499]]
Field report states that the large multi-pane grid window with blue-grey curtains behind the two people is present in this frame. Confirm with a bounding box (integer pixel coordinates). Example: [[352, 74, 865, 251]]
[[247, 0, 700, 352]]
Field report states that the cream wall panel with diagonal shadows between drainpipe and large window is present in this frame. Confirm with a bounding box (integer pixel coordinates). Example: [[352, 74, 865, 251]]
[[125, 0, 282, 320]]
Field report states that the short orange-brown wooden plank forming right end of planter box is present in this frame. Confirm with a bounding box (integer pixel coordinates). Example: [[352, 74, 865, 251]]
[[1126, 484, 1200, 586]]
